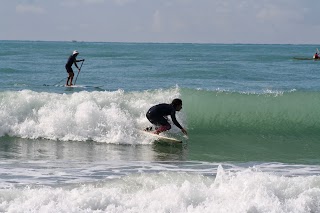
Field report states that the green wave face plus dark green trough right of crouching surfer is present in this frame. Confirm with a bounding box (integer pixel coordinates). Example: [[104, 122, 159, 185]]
[[182, 89, 320, 163]]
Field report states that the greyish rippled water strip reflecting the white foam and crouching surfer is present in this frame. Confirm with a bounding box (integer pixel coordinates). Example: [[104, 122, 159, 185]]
[[0, 136, 187, 162]]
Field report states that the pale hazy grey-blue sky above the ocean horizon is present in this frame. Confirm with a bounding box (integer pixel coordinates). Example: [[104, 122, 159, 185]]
[[0, 0, 320, 44]]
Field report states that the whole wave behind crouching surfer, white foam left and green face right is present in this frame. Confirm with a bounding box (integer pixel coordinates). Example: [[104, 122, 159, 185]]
[[0, 87, 320, 144]]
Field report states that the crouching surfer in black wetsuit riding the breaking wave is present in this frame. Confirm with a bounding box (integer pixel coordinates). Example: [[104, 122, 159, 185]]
[[146, 98, 188, 135]]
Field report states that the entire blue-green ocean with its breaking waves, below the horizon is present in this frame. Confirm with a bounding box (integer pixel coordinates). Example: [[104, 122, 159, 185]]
[[0, 41, 320, 213]]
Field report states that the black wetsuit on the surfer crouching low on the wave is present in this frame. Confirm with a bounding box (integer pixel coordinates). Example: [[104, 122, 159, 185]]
[[146, 104, 182, 129]]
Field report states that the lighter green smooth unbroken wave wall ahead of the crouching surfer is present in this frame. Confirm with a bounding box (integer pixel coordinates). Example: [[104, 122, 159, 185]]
[[182, 89, 320, 135]]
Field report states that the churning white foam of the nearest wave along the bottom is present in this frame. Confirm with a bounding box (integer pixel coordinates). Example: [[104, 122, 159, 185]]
[[0, 167, 320, 213]]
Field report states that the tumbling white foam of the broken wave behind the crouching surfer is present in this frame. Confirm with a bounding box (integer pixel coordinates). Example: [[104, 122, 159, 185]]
[[0, 88, 185, 144]]
